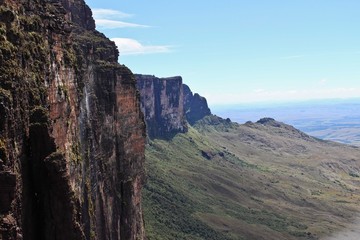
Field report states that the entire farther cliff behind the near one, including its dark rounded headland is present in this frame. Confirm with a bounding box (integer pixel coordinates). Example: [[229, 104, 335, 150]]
[[135, 74, 211, 139]]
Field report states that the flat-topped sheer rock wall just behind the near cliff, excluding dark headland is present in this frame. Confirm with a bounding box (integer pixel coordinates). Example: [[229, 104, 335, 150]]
[[135, 74, 187, 139]]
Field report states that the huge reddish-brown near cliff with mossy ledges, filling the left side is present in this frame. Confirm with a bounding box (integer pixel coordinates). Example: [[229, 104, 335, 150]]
[[0, 0, 145, 239]]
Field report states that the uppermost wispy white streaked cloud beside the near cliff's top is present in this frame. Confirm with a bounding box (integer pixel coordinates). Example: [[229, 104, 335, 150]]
[[92, 8, 149, 29]]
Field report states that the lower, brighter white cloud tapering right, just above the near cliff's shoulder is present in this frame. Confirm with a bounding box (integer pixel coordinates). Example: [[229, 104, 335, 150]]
[[111, 38, 170, 55]]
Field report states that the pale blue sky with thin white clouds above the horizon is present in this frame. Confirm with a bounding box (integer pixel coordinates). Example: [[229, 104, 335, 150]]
[[86, 0, 360, 105]]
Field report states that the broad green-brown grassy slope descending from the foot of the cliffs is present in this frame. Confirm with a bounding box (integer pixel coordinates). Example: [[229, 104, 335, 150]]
[[143, 118, 360, 239]]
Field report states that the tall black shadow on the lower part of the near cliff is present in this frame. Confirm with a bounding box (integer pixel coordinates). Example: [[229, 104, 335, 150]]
[[21, 107, 82, 239]]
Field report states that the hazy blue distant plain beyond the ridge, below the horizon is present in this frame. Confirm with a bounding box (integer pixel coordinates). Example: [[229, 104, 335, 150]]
[[213, 99, 360, 146]]
